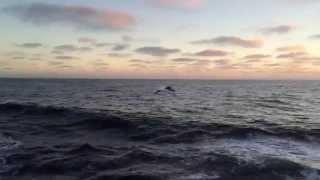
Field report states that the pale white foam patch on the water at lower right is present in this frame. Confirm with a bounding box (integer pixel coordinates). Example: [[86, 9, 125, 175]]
[[201, 136, 320, 169]]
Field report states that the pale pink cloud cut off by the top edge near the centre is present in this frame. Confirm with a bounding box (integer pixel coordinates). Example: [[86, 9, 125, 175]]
[[145, 0, 206, 9]]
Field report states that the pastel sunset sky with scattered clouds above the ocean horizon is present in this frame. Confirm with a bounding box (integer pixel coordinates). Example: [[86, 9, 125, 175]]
[[0, 0, 320, 79]]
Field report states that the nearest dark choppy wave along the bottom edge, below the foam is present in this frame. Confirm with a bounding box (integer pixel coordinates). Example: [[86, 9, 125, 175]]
[[2, 144, 320, 180]]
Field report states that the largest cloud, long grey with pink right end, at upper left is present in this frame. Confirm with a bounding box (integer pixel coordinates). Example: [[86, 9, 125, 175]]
[[3, 3, 136, 30]]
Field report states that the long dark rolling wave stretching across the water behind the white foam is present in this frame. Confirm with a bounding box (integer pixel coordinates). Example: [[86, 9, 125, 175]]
[[0, 103, 320, 142]]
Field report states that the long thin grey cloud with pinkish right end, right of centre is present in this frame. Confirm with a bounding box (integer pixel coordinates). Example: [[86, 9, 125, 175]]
[[191, 36, 264, 48]]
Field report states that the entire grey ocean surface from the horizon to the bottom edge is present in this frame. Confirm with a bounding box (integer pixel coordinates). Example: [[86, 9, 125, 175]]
[[0, 79, 320, 180]]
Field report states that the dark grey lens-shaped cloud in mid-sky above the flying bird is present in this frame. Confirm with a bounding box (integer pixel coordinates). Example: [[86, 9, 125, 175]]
[[135, 46, 180, 57]]
